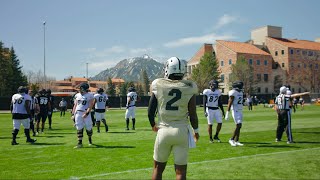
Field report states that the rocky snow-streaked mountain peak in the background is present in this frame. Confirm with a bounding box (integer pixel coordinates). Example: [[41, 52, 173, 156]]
[[91, 55, 164, 81]]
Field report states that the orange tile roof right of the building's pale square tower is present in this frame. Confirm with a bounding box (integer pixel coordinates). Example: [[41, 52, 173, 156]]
[[268, 37, 320, 51]]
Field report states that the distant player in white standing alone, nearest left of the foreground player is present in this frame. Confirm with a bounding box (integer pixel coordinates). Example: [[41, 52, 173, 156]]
[[125, 87, 138, 130]]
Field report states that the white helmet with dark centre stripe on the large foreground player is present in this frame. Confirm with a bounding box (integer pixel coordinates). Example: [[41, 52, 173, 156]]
[[164, 57, 187, 78]]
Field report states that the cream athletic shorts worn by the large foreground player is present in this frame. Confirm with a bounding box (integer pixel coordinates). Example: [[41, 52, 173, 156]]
[[153, 125, 189, 165]]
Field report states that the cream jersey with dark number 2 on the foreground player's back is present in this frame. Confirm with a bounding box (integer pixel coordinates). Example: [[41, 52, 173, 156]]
[[151, 78, 198, 125]]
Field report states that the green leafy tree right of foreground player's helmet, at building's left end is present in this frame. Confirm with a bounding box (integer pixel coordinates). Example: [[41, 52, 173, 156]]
[[191, 53, 219, 91]]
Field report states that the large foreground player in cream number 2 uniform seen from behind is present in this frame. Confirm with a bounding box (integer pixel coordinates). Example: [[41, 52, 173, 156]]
[[148, 57, 199, 179]]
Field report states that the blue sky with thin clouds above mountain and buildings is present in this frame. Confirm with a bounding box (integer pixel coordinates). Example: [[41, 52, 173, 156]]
[[0, 0, 320, 80]]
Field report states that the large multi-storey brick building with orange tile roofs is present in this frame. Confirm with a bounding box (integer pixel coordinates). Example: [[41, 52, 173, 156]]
[[188, 26, 320, 94]]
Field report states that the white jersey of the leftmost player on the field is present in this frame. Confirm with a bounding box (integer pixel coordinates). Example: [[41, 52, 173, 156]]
[[11, 93, 31, 114]]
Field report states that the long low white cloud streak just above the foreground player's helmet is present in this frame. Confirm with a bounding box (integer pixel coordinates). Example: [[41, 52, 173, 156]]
[[164, 33, 236, 48]]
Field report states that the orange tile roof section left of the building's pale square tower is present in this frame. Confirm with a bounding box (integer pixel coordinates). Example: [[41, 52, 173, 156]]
[[217, 40, 270, 55]]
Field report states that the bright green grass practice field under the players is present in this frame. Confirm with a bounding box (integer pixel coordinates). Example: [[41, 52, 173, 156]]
[[0, 105, 320, 179]]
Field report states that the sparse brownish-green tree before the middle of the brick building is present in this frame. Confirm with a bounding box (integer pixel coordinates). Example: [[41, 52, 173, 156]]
[[230, 56, 256, 94]]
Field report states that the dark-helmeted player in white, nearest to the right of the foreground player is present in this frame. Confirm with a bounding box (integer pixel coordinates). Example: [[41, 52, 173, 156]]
[[203, 80, 224, 143]]
